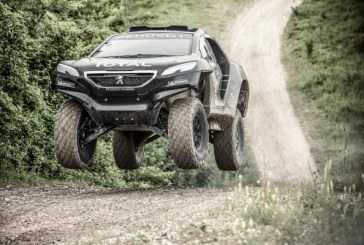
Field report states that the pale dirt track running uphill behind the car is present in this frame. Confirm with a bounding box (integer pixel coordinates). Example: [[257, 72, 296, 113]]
[[231, 0, 316, 183]]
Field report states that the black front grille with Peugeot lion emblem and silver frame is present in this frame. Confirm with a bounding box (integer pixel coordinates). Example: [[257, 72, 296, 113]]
[[87, 72, 154, 88]]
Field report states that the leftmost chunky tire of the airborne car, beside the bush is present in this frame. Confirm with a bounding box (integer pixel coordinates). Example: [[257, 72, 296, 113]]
[[54, 100, 97, 169]]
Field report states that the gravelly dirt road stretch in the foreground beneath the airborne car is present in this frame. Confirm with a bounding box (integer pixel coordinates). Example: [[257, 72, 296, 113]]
[[0, 186, 229, 244]]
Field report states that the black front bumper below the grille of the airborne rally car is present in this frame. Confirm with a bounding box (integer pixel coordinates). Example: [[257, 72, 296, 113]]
[[54, 72, 200, 126]]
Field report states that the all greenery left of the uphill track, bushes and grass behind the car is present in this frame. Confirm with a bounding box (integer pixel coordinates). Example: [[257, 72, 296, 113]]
[[0, 0, 253, 187]]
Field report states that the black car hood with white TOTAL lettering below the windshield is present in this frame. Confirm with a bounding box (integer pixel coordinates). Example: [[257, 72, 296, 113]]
[[61, 55, 204, 73]]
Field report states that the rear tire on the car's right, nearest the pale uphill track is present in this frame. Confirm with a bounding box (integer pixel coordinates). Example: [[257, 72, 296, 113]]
[[213, 110, 244, 171]]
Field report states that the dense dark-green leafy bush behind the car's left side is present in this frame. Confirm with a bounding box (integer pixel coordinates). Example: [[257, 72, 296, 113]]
[[0, 0, 169, 185]]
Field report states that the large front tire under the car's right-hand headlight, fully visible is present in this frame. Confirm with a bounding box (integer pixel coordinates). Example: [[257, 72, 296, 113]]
[[168, 98, 209, 169]]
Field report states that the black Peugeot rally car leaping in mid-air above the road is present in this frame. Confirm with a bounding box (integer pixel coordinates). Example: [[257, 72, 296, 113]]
[[54, 26, 249, 170]]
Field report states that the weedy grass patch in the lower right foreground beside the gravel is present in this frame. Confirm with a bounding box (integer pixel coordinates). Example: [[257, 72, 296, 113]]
[[218, 184, 364, 244]]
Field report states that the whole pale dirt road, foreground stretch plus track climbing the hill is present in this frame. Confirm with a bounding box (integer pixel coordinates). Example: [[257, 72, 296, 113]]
[[0, 0, 315, 244]]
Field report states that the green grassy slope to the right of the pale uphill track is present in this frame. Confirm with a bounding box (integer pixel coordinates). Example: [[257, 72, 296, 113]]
[[283, 0, 364, 190]]
